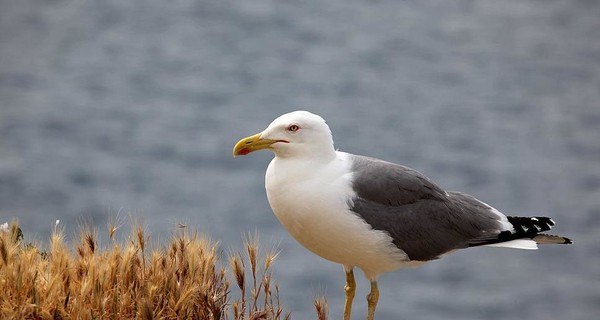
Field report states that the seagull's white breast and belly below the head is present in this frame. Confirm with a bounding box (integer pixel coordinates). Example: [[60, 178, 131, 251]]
[[265, 152, 408, 279]]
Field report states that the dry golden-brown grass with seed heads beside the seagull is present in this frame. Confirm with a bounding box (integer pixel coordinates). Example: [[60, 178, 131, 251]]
[[0, 222, 327, 320]]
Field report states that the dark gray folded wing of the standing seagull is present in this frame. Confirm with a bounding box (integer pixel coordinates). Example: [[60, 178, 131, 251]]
[[350, 155, 502, 261]]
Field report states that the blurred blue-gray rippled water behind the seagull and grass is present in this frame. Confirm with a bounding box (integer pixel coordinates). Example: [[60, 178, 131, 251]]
[[0, 0, 600, 319]]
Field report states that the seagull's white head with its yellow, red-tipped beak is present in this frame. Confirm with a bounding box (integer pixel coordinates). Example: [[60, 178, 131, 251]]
[[233, 111, 335, 159]]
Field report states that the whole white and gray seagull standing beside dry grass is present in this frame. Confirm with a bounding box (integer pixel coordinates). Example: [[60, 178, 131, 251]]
[[233, 111, 572, 320]]
